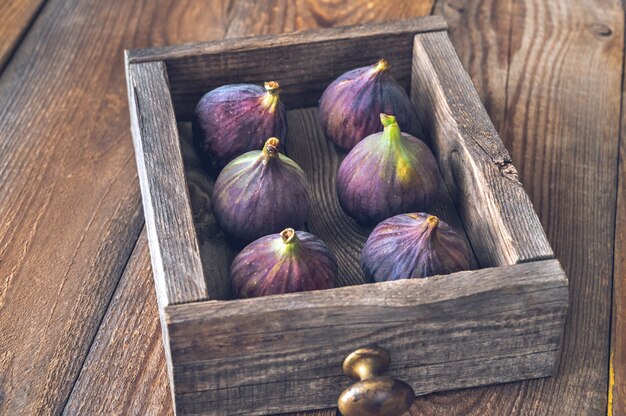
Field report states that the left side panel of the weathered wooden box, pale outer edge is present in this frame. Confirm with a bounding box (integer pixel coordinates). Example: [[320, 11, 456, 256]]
[[127, 61, 211, 307]]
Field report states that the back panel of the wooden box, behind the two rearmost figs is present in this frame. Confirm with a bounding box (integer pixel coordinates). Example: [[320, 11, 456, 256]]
[[128, 17, 446, 120]]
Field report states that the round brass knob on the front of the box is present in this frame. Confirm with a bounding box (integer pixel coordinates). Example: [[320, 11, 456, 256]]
[[337, 348, 415, 416]]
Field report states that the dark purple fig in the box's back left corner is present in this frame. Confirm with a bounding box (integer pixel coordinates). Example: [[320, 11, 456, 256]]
[[192, 81, 287, 171]]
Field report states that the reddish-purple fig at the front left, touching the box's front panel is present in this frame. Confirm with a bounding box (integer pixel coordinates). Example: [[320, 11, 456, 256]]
[[230, 228, 338, 298]]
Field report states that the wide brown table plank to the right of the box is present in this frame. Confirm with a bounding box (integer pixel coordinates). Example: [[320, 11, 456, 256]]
[[413, 0, 624, 415]]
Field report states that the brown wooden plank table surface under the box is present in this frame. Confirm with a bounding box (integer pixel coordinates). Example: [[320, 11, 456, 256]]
[[0, 0, 626, 416]]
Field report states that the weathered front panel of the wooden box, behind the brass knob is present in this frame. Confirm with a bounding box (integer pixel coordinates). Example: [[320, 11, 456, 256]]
[[166, 260, 567, 415]]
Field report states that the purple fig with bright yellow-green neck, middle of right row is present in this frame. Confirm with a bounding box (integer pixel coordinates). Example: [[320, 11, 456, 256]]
[[337, 114, 439, 224]]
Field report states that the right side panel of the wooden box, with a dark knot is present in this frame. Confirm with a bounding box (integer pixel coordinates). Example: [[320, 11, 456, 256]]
[[411, 32, 554, 267]]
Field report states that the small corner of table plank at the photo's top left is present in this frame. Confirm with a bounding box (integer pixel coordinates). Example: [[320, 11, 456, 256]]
[[0, 0, 46, 72]]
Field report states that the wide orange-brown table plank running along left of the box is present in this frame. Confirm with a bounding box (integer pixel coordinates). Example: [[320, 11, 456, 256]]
[[0, 0, 232, 415]]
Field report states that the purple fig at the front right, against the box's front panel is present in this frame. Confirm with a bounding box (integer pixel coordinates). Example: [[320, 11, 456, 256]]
[[361, 212, 471, 282]]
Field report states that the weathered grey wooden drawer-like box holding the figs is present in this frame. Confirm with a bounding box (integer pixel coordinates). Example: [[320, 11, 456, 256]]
[[126, 17, 568, 415]]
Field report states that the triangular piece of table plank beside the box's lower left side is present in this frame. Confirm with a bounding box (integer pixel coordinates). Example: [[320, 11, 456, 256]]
[[63, 230, 172, 415]]
